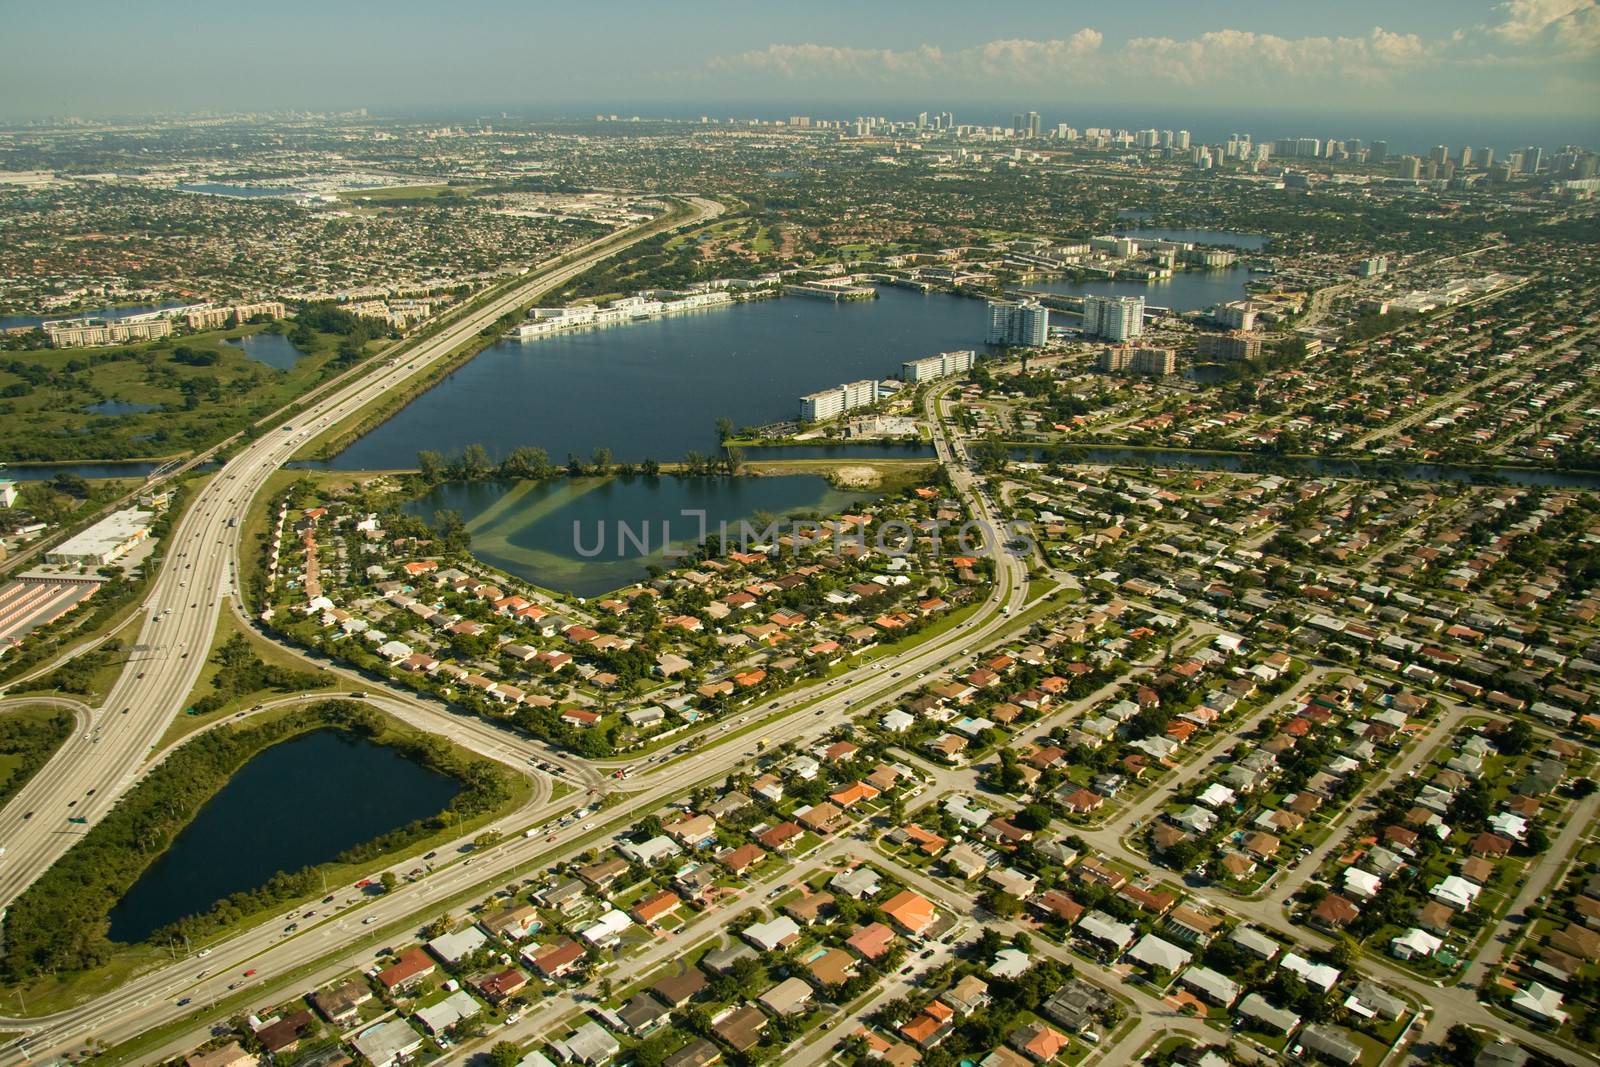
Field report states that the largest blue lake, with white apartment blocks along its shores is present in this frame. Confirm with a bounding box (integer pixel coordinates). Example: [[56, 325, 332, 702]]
[[331, 286, 992, 470]]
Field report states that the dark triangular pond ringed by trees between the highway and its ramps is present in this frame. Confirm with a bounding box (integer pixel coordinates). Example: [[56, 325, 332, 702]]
[[109, 729, 461, 944]]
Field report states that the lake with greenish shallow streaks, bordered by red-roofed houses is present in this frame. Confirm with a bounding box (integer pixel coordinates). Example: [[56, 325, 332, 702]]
[[405, 475, 877, 597]]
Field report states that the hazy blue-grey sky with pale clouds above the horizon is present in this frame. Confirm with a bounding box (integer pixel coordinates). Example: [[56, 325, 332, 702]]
[[0, 0, 1600, 136]]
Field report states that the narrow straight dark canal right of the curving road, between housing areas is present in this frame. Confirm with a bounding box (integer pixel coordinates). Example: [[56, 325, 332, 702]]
[[1011, 445, 1600, 490]]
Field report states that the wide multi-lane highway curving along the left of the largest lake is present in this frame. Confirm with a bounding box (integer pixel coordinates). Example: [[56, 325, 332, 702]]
[[0, 198, 722, 905]]
